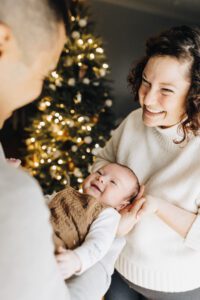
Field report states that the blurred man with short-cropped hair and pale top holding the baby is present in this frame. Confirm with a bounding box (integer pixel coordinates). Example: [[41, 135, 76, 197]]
[[0, 0, 123, 300]]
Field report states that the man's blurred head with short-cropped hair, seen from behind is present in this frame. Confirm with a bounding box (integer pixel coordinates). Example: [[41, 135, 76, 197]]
[[0, 0, 68, 128]]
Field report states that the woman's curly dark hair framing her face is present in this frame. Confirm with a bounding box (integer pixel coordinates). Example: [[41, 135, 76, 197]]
[[128, 25, 200, 143]]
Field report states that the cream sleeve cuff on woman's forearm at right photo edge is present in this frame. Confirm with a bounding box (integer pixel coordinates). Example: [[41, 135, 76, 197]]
[[185, 198, 200, 251]]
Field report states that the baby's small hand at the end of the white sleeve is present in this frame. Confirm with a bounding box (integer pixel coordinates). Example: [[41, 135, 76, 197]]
[[56, 247, 81, 279]]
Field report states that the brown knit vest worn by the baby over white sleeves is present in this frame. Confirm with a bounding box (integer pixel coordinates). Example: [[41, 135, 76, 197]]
[[49, 186, 105, 249]]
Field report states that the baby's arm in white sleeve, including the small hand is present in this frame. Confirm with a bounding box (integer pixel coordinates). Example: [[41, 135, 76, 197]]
[[56, 208, 120, 279]]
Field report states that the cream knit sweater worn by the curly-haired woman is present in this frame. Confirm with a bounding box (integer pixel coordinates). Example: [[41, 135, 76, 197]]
[[94, 109, 200, 292]]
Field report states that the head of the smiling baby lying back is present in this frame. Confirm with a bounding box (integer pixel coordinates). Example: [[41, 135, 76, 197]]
[[83, 163, 140, 210]]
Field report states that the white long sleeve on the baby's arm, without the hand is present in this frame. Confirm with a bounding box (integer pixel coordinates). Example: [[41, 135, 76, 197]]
[[74, 208, 120, 275]]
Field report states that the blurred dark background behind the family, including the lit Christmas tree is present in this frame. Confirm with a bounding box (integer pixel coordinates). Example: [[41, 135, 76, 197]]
[[0, 0, 200, 193]]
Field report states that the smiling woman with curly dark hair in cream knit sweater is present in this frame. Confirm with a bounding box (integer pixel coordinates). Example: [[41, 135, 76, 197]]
[[94, 26, 200, 300]]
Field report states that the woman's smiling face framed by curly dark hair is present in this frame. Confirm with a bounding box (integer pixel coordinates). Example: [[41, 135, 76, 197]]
[[139, 56, 190, 127]]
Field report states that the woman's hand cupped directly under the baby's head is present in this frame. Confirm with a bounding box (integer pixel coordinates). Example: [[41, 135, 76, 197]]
[[117, 186, 145, 236]]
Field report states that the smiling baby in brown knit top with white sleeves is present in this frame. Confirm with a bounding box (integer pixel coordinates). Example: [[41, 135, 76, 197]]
[[49, 163, 140, 279]]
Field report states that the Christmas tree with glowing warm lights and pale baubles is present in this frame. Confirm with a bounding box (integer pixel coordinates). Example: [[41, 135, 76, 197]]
[[24, 0, 114, 193]]
